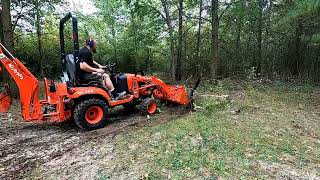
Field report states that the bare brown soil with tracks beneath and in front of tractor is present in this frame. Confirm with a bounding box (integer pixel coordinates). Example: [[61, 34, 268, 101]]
[[0, 101, 188, 179]]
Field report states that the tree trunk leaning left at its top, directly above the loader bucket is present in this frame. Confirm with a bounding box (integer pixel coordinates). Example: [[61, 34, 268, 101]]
[[161, 0, 176, 81]]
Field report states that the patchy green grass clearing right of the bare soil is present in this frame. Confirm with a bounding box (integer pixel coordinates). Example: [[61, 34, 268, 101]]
[[99, 82, 320, 179]]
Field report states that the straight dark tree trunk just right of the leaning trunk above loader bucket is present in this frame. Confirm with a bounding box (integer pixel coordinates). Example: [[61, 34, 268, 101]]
[[176, 0, 183, 81]]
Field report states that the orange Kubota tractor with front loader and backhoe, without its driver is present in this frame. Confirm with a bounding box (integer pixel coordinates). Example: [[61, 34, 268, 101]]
[[0, 13, 196, 130]]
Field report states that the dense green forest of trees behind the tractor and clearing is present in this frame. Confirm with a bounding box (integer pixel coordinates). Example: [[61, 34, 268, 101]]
[[0, 0, 320, 82]]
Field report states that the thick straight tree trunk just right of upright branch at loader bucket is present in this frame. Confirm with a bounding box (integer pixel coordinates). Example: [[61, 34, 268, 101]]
[[211, 0, 220, 78]]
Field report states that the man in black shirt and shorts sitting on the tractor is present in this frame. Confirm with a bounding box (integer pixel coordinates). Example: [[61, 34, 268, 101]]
[[79, 38, 126, 100]]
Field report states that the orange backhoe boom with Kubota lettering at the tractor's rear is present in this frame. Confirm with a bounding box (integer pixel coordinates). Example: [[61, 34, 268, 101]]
[[0, 43, 42, 121]]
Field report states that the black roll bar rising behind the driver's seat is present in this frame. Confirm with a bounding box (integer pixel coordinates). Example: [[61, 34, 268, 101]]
[[59, 12, 79, 67]]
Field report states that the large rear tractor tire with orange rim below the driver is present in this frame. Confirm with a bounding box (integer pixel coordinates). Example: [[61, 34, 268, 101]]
[[73, 98, 108, 131]]
